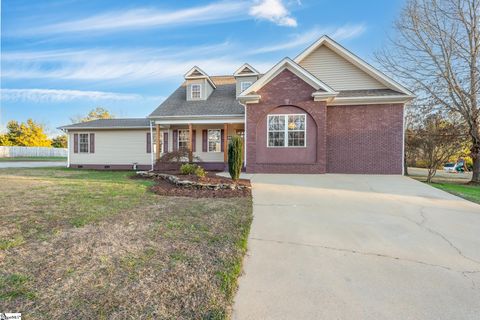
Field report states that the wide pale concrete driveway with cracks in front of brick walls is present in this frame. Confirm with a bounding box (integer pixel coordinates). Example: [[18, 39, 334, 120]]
[[233, 175, 480, 320]]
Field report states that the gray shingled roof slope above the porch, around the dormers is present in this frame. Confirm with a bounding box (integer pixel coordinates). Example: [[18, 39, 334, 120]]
[[150, 81, 245, 117]]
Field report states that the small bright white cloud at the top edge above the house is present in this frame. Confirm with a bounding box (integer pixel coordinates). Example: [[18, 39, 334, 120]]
[[249, 0, 297, 27]]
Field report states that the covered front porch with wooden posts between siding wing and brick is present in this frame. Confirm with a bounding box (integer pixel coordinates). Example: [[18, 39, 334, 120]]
[[152, 119, 245, 171]]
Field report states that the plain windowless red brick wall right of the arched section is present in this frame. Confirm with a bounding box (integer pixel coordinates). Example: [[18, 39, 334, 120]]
[[327, 104, 403, 174]]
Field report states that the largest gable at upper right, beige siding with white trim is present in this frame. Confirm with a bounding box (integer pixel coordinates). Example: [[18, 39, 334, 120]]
[[294, 36, 413, 96]]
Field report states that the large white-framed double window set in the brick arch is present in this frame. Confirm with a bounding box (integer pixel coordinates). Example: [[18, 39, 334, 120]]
[[267, 114, 306, 147]]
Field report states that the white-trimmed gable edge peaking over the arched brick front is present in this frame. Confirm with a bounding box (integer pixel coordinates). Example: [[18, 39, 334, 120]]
[[239, 58, 337, 99]]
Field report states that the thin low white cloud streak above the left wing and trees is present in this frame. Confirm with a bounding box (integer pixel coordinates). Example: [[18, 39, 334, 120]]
[[0, 89, 143, 102]]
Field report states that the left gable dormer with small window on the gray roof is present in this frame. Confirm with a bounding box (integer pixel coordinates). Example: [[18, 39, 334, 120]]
[[185, 66, 216, 101]]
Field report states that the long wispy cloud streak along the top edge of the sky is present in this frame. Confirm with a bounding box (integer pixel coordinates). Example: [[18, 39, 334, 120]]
[[23, 1, 249, 34]]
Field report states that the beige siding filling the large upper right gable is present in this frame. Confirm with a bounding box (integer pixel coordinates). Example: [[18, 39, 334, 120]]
[[299, 46, 386, 91]]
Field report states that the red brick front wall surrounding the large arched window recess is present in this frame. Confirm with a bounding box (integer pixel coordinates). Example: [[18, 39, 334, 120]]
[[246, 70, 327, 173]]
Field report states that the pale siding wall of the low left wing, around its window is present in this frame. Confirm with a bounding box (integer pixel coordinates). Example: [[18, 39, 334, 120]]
[[68, 129, 150, 165]]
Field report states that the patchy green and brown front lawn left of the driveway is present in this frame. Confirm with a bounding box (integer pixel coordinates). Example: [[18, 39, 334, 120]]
[[0, 168, 252, 319]]
